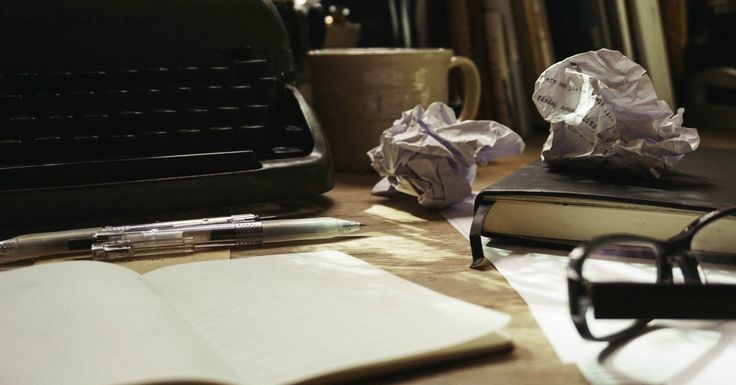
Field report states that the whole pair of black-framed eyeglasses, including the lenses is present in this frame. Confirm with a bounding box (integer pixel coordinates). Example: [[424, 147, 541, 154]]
[[567, 206, 736, 341]]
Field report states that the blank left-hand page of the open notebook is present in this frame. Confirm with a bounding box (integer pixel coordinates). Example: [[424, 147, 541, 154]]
[[0, 261, 238, 385]]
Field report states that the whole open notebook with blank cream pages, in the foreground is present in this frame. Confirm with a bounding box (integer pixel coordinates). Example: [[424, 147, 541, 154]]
[[0, 252, 512, 385]]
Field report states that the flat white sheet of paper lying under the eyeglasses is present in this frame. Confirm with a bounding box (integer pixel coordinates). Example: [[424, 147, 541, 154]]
[[442, 205, 736, 384]]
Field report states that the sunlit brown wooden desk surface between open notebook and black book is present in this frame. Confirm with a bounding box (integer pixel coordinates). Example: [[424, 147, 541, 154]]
[[206, 134, 585, 384]]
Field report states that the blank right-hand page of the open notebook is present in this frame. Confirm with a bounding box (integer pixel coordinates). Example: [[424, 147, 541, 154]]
[[146, 252, 509, 384]]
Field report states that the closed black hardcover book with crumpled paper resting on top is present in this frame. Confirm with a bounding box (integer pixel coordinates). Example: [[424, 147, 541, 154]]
[[470, 148, 736, 263]]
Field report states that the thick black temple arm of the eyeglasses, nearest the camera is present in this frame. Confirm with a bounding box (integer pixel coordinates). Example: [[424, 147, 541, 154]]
[[591, 282, 736, 319]]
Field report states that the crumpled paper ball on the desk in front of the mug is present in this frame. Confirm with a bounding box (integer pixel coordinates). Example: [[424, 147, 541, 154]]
[[368, 102, 524, 208]]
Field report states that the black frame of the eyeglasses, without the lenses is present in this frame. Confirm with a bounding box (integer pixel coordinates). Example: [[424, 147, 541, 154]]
[[567, 206, 736, 342]]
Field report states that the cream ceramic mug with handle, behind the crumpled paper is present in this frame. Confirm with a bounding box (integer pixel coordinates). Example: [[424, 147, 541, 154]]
[[308, 48, 480, 171]]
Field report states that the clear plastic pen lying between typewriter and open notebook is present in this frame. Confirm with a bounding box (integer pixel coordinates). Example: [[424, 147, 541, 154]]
[[0, 214, 362, 264]]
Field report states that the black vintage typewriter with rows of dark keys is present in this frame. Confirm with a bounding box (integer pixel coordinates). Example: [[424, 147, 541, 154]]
[[0, 0, 333, 235]]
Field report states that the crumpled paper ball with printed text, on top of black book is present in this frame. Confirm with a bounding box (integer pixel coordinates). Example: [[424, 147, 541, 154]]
[[532, 49, 700, 178]]
